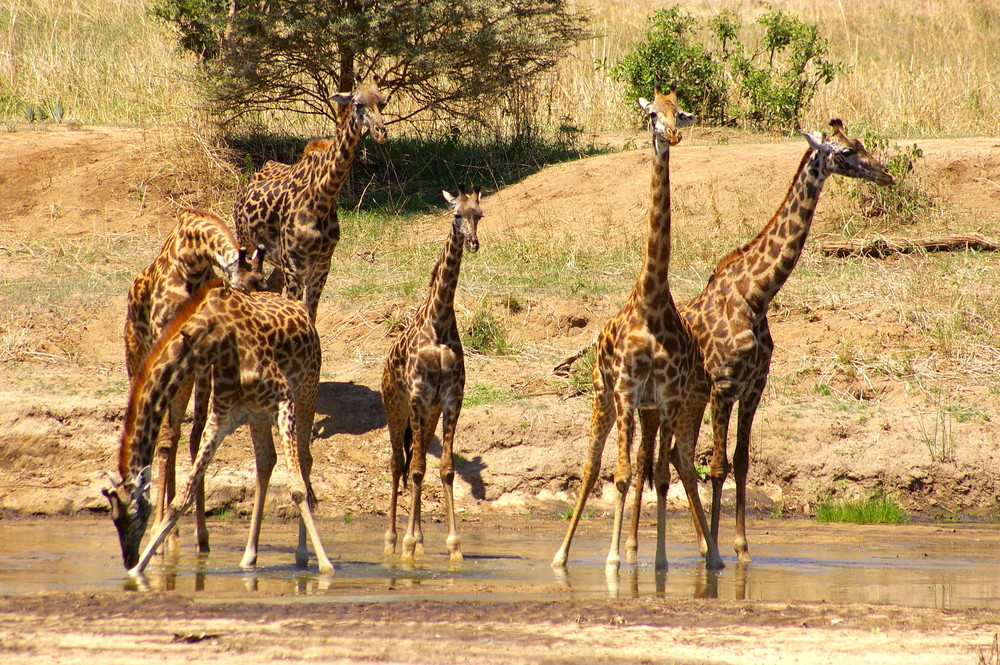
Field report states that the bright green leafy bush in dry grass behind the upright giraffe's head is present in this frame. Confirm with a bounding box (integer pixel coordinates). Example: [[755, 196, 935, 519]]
[[611, 5, 844, 130]]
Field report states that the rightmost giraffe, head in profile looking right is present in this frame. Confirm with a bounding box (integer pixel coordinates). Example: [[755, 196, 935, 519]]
[[628, 119, 893, 563]]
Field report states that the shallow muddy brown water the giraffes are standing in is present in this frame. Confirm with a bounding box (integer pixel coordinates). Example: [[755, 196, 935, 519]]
[[0, 517, 1000, 609]]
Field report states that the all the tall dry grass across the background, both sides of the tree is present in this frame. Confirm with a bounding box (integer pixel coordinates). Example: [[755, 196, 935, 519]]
[[0, 0, 1000, 136]]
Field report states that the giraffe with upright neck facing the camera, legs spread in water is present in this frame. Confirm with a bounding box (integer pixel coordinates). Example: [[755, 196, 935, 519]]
[[552, 86, 723, 575]]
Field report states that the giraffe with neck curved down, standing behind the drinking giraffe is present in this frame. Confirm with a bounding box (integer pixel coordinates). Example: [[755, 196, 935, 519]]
[[125, 208, 264, 552]]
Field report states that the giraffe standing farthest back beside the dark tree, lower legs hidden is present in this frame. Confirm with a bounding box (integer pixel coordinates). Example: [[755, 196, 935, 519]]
[[233, 76, 386, 321]]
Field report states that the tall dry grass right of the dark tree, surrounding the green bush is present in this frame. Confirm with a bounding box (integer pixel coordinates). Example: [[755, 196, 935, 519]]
[[547, 0, 1000, 136]]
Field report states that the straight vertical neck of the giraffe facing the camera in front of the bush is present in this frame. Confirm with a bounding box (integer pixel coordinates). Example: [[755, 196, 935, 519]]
[[634, 137, 673, 311]]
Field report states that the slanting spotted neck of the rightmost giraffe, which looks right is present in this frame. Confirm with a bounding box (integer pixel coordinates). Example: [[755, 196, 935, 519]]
[[740, 150, 829, 316]]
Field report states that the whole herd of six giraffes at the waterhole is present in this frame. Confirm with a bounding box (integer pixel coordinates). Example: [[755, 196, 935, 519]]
[[104, 78, 893, 576]]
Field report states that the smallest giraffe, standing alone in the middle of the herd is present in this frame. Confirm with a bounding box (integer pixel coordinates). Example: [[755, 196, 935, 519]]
[[382, 185, 483, 561]]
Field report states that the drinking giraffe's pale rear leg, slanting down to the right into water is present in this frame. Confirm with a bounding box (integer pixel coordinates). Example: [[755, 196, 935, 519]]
[[278, 399, 333, 574]]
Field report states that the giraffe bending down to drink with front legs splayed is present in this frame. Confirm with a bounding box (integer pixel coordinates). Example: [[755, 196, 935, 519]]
[[104, 280, 333, 577]]
